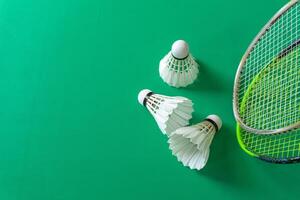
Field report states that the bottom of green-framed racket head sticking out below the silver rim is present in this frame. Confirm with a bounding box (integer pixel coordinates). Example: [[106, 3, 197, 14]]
[[236, 124, 300, 164]]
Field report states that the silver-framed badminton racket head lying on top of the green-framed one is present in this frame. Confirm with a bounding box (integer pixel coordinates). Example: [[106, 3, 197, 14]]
[[233, 0, 300, 134]]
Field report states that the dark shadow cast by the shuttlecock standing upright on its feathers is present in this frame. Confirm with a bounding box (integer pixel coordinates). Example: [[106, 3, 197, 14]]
[[186, 60, 226, 92]]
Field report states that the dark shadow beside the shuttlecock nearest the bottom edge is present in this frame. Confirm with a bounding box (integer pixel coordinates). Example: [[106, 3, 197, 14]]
[[198, 125, 255, 187]]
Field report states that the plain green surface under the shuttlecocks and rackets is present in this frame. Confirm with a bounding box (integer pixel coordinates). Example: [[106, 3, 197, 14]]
[[0, 0, 300, 200]]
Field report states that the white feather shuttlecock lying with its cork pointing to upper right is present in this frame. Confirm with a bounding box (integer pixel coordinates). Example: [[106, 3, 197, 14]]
[[168, 115, 222, 170]]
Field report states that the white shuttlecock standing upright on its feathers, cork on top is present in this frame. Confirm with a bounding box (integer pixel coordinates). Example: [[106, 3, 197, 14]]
[[159, 40, 199, 87]]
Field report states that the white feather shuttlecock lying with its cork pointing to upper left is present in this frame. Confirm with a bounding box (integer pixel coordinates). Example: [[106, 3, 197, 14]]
[[138, 89, 194, 135]]
